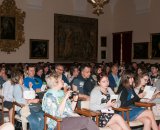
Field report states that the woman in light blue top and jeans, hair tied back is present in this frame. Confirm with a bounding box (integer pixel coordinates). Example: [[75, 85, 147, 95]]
[[12, 73, 44, 130]]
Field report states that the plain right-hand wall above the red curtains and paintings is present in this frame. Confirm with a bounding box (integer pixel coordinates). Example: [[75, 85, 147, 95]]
[[112, 0, 160, 63]]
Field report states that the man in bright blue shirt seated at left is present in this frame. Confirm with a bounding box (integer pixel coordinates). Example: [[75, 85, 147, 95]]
[[24, 65, 43, 91]]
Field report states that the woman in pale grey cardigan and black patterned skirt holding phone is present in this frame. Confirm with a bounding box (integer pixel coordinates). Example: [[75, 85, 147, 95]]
[[90, 74, 130, 130]]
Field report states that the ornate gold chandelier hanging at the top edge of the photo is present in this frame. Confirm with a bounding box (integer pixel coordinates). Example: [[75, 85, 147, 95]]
[[88, 0, 110, 16]]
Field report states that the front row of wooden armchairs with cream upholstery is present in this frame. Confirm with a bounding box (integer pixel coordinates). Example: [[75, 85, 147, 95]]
[[0, 96, 159, 130]]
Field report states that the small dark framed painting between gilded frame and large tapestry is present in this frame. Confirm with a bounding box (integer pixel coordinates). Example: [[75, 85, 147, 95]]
[[30, 39, 49, 59]]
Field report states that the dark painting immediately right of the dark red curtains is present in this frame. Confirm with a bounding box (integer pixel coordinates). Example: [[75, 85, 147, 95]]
[[133, 42, 149, 59]]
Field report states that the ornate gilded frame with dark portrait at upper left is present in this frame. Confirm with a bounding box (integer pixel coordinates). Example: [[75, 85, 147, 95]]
[[0, 0, 25, 53]]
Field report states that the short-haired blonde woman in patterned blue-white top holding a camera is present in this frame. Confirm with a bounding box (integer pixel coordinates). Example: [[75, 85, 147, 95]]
[[42, 73, 98, 130]]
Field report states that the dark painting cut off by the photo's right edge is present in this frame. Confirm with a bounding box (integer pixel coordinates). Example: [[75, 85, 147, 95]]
[[151, 33, 160, 59]]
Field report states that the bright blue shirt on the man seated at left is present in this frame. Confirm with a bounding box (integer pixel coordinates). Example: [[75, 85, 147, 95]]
[[24, 77, 43, 90]]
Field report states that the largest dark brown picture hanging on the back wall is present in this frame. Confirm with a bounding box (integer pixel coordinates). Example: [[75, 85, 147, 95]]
[[54, 14, 98, 62]]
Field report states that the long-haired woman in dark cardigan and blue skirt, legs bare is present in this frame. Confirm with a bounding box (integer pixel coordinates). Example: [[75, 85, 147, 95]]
[[120, 71, 158, 130]]
